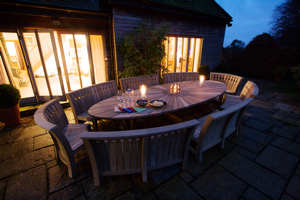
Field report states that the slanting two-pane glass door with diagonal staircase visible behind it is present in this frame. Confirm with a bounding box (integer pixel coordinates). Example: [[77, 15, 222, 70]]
[[20, 30, 65, 102]]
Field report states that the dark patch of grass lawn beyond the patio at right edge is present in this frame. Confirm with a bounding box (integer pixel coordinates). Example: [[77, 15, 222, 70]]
[[269, 80, 300, 100]]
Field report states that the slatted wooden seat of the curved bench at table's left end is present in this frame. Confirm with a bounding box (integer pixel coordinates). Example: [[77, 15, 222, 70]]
[[62, 124, 89, 153]]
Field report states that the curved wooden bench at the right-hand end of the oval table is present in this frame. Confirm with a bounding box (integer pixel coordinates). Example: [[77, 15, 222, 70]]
[[221, 81, 259, 109]]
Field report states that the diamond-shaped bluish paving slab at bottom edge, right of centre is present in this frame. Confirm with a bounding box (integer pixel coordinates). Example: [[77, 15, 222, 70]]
[[191, 165, 248, 200]]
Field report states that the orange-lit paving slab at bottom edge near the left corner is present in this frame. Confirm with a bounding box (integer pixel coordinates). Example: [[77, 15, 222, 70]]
[[5, 165, 47, 200]]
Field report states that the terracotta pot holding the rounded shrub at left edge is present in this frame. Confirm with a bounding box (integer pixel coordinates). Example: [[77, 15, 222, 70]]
[[0, 104, 21, 127]]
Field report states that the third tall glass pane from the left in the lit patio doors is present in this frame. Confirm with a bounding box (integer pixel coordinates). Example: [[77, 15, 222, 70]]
[[38, 33, 62, 95]]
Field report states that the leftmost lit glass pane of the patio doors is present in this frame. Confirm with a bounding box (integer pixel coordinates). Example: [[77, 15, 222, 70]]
[[0, 33, 34, 98]]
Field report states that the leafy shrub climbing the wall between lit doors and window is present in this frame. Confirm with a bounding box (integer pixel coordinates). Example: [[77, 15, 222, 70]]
[[119, 20, 170, 78]]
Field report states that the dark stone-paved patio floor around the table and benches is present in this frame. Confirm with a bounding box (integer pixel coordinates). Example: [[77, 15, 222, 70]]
[[0, 80, 300, 200]]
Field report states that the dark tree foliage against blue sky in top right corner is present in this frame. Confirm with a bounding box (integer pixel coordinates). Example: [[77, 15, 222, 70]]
[[271, 0, 300, 48]]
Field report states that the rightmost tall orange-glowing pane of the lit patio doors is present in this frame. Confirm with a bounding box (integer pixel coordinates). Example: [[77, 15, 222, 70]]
[[90, 35, 106, 83]]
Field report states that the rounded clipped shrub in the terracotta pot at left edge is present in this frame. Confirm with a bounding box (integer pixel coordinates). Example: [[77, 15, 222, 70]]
[[0, 84, 21, 108]]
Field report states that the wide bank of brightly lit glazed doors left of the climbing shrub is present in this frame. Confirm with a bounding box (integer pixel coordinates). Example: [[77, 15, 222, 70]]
[[0, 29, 107, 104]]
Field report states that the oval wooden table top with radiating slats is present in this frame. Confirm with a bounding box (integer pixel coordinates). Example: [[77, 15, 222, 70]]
[[88, 81, 227, 120]]
